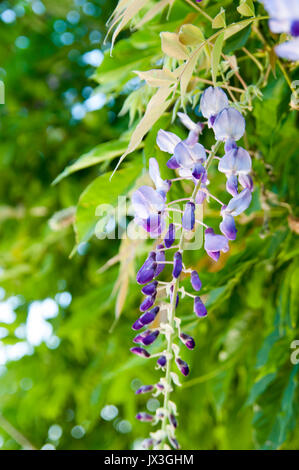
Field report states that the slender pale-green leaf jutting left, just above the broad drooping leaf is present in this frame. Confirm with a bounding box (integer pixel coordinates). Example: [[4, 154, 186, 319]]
[[52, 140, 135, 185]]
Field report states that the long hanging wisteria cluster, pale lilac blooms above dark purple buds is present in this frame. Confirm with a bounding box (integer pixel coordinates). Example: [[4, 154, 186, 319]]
[[131, 87, 253, 449]]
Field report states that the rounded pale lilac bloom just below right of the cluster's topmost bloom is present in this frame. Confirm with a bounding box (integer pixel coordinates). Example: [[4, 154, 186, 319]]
[[213, 108, 245, 141]]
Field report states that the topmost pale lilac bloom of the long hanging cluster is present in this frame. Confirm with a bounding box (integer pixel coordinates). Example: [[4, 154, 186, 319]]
[[200, 86, 229, 127]]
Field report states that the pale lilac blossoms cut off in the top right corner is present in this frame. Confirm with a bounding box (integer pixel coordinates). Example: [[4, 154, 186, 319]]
[[262, 0, 299, 61]]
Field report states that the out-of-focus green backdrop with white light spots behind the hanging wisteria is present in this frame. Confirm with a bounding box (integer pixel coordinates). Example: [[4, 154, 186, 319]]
[[0, 0, 299, 450]]
